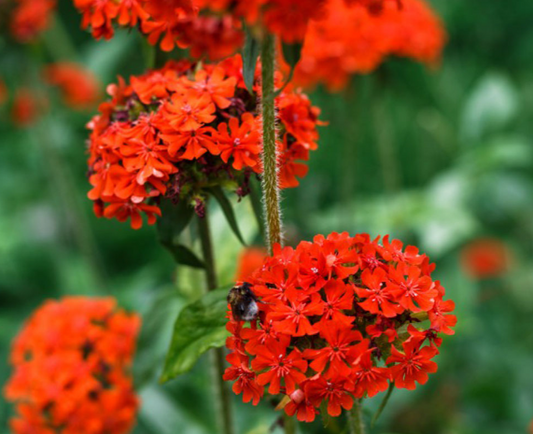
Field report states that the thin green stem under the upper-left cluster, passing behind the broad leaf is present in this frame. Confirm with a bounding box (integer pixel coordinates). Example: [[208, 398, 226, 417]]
[[197, 213, 234, 434]]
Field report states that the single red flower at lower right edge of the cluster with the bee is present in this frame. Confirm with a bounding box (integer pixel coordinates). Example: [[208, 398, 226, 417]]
[[387, 339, 438, 390]]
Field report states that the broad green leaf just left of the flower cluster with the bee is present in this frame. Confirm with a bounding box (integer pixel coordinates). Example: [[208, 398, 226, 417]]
[[160, 287, 229, 383]]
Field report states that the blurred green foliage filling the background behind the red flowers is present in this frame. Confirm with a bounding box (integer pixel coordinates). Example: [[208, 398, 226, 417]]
[[0, 0, 533, 434]]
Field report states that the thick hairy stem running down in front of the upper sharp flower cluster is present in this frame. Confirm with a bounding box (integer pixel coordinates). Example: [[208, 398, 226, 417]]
[[261, 33, 282, 253]]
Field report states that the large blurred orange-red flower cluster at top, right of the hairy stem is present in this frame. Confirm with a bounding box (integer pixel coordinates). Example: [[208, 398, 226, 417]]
[[295, 0, 446, 90]]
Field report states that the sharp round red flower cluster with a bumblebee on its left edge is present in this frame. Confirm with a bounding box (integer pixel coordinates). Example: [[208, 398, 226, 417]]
[[224, 233, 457, 422]]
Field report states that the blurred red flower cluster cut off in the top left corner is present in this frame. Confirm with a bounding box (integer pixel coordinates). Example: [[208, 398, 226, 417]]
[[9, 0, 56, 43]]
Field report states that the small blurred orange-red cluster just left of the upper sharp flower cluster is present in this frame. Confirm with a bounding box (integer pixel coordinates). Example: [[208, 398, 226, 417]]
[[43, 62, 100, 109]]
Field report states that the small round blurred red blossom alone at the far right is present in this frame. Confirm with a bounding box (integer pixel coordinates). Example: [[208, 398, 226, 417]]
[[461, 238, 511, 280]]
